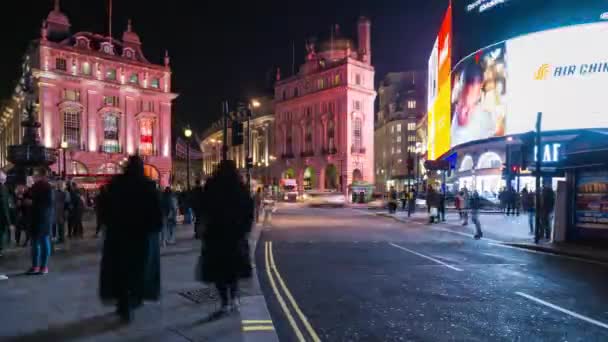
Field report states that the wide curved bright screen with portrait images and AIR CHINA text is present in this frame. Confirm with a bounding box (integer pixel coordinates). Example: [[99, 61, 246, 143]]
[[451, 23, 608, 147]]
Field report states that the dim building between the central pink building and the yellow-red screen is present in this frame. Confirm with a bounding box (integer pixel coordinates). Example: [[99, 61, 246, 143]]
[[374, 71, 426, 191]]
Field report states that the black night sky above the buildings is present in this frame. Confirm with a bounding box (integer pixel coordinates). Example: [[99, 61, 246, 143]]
[[0, 0, 447, 136]]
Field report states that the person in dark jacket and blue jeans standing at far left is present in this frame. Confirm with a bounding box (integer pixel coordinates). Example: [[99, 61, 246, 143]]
[[27, 169, 55, 274]]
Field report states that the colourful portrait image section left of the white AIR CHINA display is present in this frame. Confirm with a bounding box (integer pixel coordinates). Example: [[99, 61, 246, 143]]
[[451, 40, 507, 146]]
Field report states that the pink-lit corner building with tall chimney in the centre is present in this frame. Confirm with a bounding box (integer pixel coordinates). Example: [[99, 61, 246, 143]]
[[273, 17, 376, 192]]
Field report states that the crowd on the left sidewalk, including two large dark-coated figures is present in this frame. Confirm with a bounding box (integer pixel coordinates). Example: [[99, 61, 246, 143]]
[[0, 156, 274, 322]]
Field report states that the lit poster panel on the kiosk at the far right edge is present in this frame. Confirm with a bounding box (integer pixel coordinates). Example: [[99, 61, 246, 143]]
[[576, 171, 608, 229]]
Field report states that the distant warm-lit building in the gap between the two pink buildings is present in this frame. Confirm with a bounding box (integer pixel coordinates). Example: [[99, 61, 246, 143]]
[[200, 98, 276, 185]]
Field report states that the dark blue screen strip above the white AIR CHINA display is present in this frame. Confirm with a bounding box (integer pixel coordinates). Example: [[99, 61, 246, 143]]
[[451, 0, 608, 61]]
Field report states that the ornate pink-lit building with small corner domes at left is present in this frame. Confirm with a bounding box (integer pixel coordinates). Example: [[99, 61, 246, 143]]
[[0, 0, 177, 187]]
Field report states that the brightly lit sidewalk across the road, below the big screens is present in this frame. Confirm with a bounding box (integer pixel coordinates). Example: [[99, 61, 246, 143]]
[[373, 209, 608, 262]]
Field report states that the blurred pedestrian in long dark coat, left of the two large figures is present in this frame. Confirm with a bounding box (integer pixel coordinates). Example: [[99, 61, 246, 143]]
[[99, 156, 163, 322]]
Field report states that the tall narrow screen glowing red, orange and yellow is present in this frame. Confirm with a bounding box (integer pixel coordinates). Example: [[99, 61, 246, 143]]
[[428, 7, 452, 160]]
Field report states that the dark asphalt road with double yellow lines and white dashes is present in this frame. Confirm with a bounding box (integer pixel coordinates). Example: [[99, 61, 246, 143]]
[[256, 206, 608, 341]]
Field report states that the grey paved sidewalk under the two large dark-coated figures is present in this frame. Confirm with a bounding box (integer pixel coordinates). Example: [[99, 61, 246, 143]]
[[0, 220, 278, 342]]
